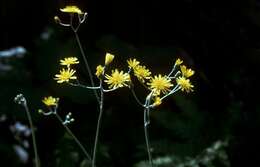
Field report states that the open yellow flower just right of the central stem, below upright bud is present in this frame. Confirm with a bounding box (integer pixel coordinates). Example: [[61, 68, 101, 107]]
[[105, 69, 130, 89]]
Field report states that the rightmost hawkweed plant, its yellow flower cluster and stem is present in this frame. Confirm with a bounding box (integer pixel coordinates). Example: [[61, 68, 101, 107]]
[[127, 59, 195, 167]]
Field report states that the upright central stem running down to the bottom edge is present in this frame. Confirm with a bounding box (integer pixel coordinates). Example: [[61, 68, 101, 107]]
[[92, 79, 104, 167]]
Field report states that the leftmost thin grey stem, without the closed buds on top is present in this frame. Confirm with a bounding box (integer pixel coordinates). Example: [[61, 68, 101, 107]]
[[23, 101, 40, 167]]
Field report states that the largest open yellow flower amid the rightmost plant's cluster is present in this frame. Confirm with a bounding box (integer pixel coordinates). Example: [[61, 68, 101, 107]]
[[148, 74, 173, 95]]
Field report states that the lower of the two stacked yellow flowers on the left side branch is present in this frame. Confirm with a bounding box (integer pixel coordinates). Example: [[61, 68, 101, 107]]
[[54, 68, 77, 83]]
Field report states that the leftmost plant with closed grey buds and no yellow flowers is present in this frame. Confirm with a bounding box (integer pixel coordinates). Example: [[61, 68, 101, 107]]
[[14, 94, 40, 167]]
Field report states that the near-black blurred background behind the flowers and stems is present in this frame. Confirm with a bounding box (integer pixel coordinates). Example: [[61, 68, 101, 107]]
[[0, 0, 260, 167]]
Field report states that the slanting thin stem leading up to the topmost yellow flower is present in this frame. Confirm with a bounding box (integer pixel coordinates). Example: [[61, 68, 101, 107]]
[[74, 31, 101, 103]]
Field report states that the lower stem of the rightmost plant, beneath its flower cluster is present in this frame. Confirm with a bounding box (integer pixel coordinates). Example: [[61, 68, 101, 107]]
[[144, 104, 153, 167]]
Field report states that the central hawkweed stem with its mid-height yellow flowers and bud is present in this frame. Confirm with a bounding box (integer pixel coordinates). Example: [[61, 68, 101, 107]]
[[53, 53, 130, 167]]
